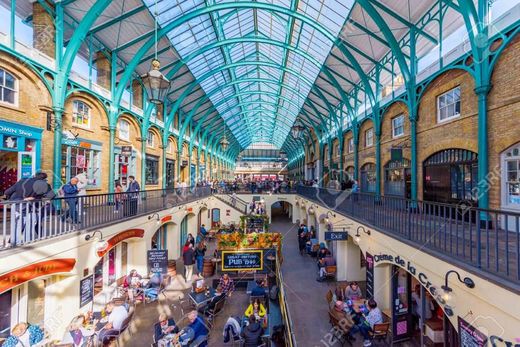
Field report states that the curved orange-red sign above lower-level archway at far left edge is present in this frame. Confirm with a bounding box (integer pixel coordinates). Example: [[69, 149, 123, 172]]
[[0, 258, 76, 293]]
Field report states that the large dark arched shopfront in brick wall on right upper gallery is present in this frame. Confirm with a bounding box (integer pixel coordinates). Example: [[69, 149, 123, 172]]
[[423, 149, 478, 203]]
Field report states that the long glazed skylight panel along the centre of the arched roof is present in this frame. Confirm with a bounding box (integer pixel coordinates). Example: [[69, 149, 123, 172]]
[[144, 0, 354, 148]]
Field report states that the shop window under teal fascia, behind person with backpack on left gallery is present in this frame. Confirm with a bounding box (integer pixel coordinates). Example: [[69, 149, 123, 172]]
[[61, 144, 101, 188]]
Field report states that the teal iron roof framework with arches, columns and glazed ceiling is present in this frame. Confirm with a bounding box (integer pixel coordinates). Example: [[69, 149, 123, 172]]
[[2, 0, 518, 207]]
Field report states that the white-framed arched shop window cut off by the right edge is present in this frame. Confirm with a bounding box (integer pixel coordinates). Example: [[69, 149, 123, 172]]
[[501, 145, 520, 210]]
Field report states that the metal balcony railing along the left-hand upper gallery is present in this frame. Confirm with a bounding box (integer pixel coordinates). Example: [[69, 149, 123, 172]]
[[0, 187, 211, 250]]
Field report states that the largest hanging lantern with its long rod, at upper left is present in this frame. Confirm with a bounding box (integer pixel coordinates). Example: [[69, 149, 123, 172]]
[[141, 0, 171, 105]]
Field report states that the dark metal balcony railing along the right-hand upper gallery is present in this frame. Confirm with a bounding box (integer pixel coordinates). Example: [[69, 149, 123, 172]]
[[297, 186, 520, 285]]
